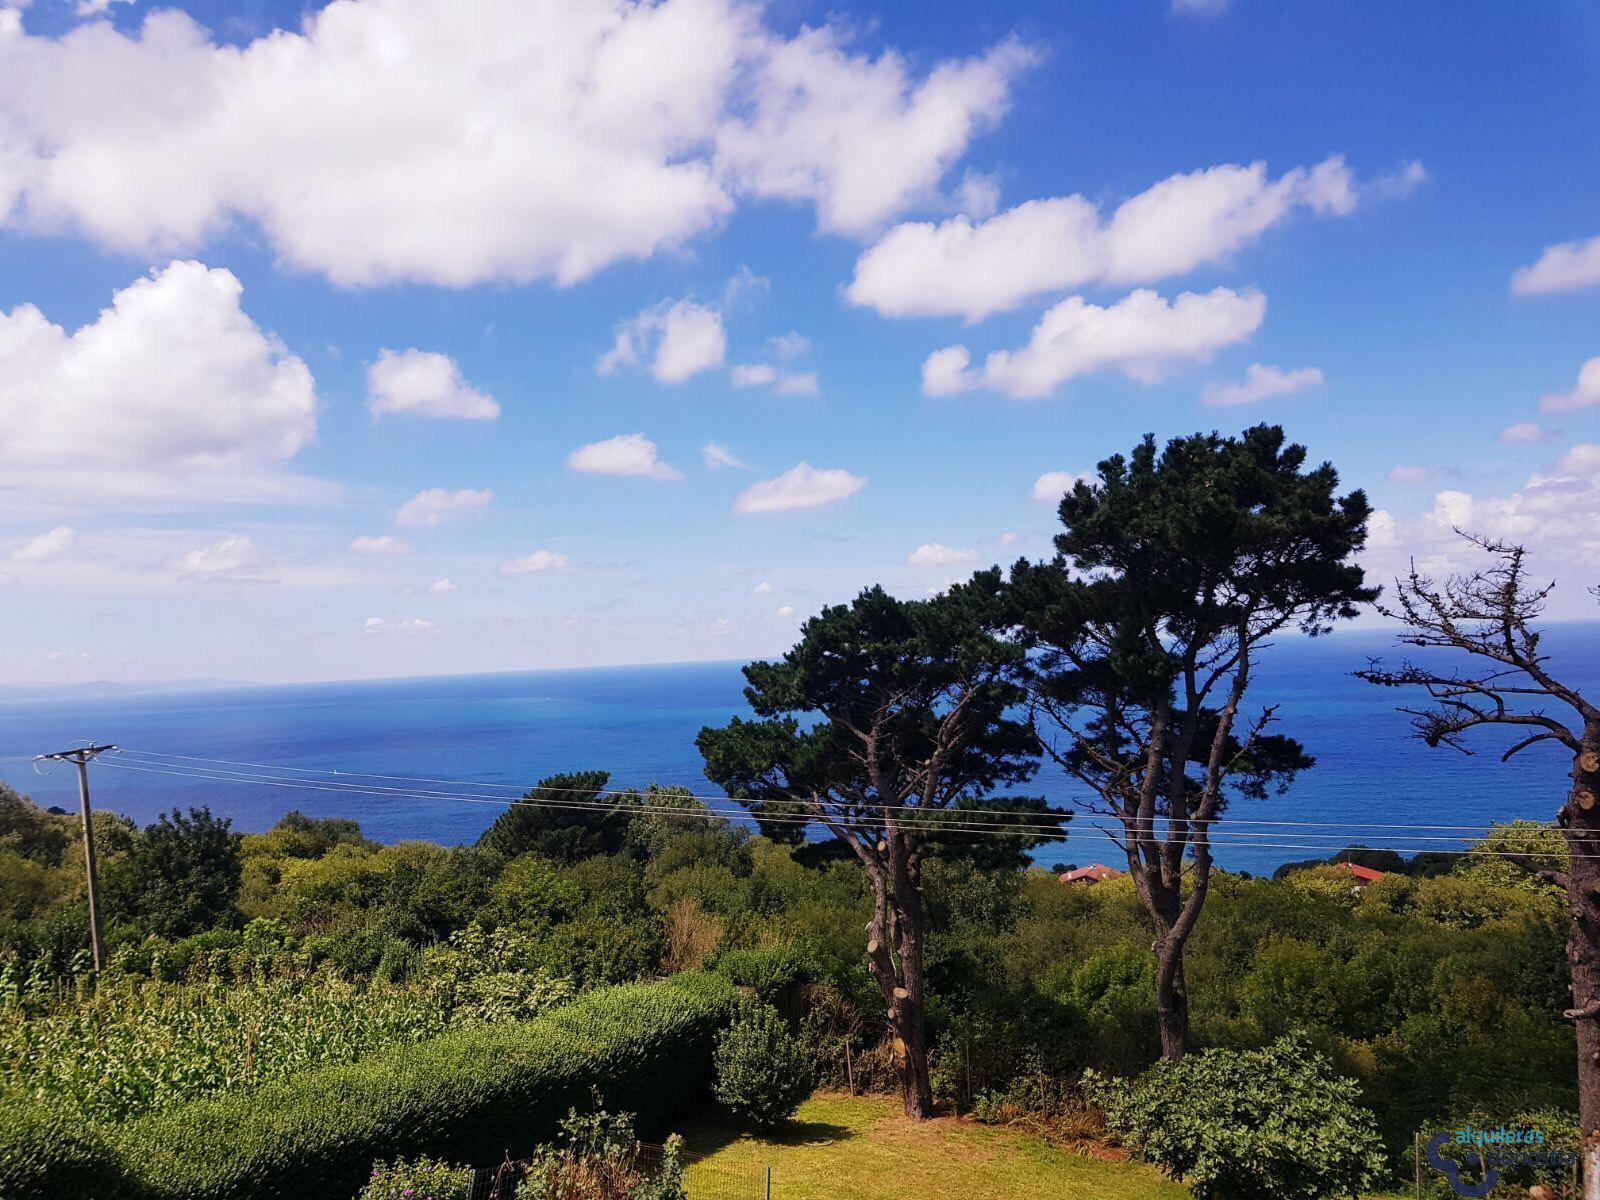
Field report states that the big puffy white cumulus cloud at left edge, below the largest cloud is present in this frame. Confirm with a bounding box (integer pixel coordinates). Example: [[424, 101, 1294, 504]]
[[0, 260, 317, 502]]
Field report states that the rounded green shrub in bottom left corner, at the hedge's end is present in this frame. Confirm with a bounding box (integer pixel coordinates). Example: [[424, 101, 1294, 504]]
[[0, 1101, 123, 1200]]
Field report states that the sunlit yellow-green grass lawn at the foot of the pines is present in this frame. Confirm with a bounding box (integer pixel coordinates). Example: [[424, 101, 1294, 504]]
[[683, 1093, 1189, 1200]]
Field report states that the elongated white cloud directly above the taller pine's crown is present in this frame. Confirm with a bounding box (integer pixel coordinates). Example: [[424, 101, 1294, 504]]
[[922, 288, 1267, 398]]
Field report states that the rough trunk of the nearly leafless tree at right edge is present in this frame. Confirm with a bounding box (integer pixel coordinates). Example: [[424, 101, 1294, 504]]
[[1562, 742, 1600, 1200]]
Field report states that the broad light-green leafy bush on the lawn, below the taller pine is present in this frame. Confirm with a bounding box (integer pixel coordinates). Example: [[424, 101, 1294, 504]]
[[1083, 1035, 1384, 1200]]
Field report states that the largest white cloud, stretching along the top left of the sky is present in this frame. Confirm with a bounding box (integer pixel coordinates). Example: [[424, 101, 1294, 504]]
[[0, 0, 1032, 286]]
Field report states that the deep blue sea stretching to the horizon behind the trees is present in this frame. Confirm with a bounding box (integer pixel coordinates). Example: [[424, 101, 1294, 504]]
[[0, 624, 1600, 872]]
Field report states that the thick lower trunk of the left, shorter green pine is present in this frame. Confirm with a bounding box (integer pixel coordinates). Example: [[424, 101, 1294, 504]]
[[867, 834, 933, 1120]]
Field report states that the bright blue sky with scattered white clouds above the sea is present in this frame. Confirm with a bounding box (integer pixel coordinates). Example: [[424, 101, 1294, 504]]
[[0, 0, 1600, 682]]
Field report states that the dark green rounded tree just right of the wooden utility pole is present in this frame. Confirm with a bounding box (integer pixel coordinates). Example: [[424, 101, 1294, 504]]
[[107, 808, 240, 938]]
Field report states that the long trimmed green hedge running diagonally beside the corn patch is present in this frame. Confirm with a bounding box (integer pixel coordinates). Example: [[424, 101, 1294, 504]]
[[0, 974, 736, 1200]]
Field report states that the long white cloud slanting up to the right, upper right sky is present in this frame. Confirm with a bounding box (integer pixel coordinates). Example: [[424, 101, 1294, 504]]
[[845, 157, 1357, 323]]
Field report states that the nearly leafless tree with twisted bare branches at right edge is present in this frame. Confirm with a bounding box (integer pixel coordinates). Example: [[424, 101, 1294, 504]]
[[1357, 530, 1600, 1200]]
